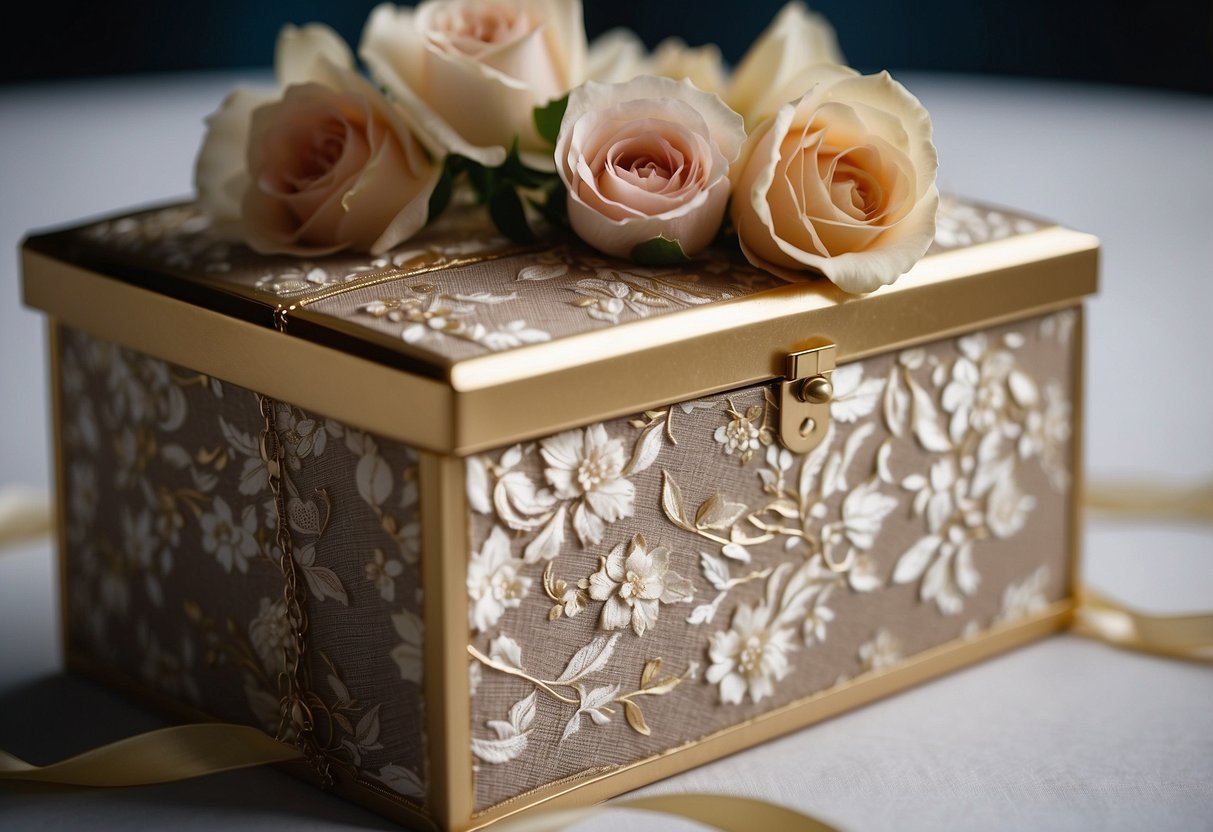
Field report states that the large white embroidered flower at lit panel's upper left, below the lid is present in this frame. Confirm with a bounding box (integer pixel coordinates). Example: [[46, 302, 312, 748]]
[[540, 424, 636, 545]]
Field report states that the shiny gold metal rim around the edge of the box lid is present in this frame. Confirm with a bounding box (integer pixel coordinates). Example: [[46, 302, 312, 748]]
[[22, 227, 1098, 456]]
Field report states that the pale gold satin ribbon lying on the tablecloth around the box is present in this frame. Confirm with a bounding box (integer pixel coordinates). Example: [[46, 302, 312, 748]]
[[0, 486, 1213, 832]]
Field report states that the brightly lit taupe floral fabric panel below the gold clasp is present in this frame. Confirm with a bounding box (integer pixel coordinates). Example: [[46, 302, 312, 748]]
[[467, 309, 1077, 816]]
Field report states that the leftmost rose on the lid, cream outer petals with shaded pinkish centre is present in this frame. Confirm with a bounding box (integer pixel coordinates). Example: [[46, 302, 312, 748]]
[[195, 25, 442, 256]]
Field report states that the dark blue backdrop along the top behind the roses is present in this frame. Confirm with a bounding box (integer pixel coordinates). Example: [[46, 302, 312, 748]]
[[9, 0, 1213, 93]]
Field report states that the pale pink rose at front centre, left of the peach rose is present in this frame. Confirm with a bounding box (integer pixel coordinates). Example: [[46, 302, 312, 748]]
[[556, 75, 745, 257]]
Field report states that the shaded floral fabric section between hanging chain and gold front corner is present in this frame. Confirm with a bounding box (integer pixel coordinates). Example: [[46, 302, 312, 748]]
[[265, 401, 427, 807]]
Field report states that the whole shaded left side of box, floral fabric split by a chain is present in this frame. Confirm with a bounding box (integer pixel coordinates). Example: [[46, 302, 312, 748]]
[[58, 329, 427, 807]]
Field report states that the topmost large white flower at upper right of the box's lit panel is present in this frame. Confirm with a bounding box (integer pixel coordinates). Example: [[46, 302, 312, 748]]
[[943, 332, 1015, 443]]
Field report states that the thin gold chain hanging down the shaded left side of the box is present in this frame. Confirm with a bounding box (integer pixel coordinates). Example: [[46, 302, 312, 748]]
[[257, 395, 332, 786]]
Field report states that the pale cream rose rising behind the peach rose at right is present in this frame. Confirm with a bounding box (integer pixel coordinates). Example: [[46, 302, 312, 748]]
[[724, 0, 845, 130]]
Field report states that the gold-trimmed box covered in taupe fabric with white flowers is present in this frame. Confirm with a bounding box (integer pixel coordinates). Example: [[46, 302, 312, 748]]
[[23, 200, 1098, 830]]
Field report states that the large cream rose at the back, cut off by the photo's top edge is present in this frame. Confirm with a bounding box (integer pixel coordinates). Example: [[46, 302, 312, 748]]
[[359, 0, 586, 170]]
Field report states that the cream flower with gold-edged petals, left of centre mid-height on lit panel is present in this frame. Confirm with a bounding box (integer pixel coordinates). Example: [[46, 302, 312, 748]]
[[590, 535, 694, 636]]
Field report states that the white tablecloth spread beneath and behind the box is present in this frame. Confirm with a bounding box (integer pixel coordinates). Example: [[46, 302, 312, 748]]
[[0, 75, 1213, 832]]
